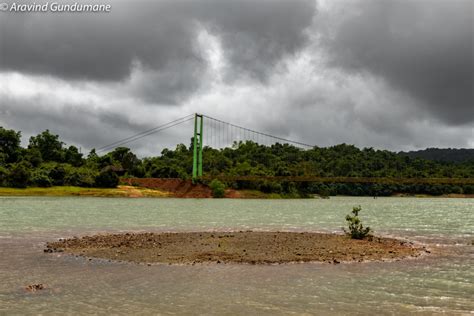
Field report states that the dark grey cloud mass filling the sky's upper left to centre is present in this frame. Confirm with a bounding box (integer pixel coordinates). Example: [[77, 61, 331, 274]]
[[0, 0, 315, 103]]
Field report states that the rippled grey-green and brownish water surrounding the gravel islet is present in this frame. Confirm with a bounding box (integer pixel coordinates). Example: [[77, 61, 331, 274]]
[[0, 197, 474, 315]]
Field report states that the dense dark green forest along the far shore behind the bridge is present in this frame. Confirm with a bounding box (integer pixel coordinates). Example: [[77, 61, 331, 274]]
[[0, 127, 474, 197]]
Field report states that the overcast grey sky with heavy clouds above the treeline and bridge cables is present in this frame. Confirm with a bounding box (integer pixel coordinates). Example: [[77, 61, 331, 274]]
[[0, 0, 474, 155]]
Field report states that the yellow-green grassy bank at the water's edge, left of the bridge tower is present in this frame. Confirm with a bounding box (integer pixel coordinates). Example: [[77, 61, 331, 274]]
[[0, 185, 169, 197]]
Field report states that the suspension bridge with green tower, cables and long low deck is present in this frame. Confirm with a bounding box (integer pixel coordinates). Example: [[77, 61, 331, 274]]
[[96, 113, 474, 185]]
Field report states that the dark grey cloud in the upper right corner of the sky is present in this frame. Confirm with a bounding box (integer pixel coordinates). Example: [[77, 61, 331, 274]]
[[322, 0, 474, 125]]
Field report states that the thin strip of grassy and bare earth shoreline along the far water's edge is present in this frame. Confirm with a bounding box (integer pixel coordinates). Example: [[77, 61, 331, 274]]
[[0, 185, 474, 199]]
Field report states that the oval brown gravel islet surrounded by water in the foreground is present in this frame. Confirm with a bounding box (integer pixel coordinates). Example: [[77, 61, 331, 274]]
[[45, 231, 422, 264]]
